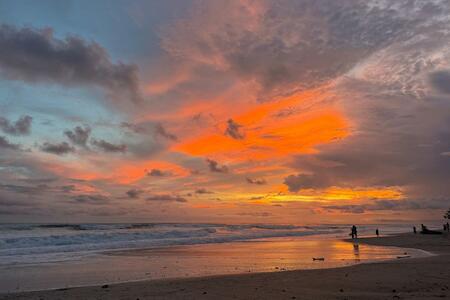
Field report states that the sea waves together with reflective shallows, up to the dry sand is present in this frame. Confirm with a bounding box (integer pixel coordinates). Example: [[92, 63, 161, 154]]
[[0, 223, 428, 292]]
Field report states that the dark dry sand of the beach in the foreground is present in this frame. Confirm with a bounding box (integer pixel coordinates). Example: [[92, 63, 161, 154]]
[[0, 234, 450, 300]]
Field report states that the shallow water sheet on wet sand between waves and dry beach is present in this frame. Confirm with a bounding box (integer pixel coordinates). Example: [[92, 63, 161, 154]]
[[0, 236, 428, 292]]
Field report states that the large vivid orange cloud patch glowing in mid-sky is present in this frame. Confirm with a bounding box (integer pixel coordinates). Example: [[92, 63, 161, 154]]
[[172, 85, 349, 161]]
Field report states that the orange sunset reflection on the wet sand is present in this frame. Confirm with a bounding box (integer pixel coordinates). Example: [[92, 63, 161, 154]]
[[110, 237, 412, 275]]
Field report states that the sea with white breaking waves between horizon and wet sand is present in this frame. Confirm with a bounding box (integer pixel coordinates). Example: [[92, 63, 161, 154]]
[[0, 223, 411, 266]]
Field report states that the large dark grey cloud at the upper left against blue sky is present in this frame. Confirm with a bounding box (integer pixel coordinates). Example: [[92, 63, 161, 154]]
[[0, 25, 141, 102]]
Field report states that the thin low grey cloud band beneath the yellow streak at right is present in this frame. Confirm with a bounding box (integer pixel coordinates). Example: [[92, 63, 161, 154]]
[[322, 198, 450, 214]]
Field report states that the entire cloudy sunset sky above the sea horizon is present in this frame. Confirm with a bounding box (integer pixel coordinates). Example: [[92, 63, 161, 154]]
[[0, 0, 450, 224]]
